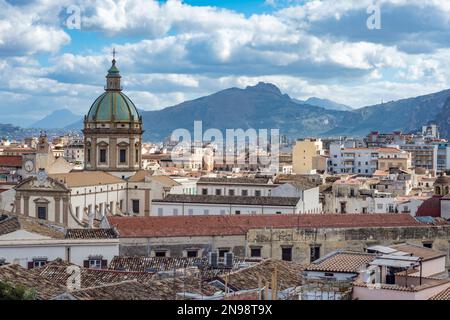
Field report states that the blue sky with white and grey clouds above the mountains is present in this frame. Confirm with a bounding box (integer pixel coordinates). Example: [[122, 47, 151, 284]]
[[0, 0, 450, 125]]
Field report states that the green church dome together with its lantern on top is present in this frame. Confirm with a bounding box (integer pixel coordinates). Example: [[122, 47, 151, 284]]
[[86, 59, 140, 122]]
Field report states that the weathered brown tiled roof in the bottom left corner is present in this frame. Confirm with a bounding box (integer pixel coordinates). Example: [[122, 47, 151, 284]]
[[0, 264, 67, 300]]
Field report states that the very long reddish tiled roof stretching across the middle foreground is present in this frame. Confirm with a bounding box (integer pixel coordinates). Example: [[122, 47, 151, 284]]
[[108, 214, 426, 238]]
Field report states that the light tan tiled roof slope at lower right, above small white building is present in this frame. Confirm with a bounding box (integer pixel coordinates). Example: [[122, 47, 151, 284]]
[[305, 251, 376, 273]]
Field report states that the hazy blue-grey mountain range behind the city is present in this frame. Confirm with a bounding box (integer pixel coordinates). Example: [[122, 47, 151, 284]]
[[7, 82, 450, 141]]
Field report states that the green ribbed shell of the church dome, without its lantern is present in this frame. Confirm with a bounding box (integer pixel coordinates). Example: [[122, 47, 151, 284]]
[[87, 91, 139, 122]]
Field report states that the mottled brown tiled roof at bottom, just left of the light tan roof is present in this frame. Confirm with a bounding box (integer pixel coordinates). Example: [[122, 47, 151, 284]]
[[219, 259, 303, 290]]
